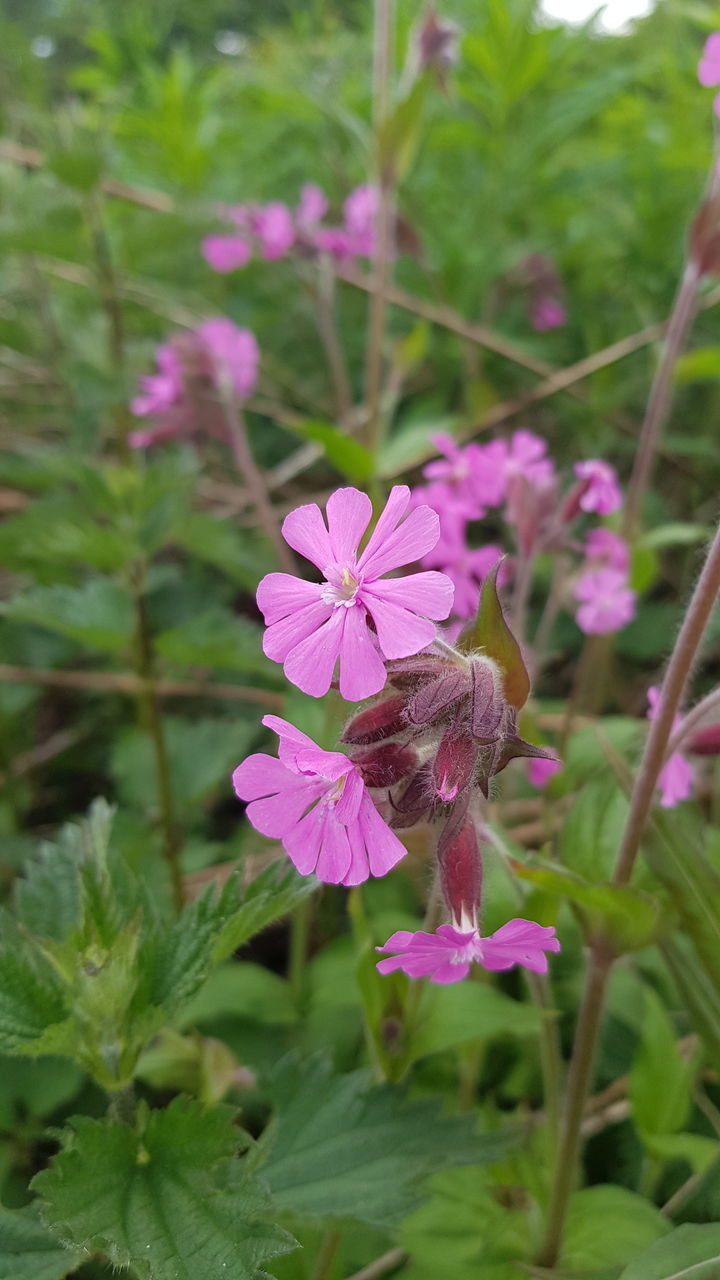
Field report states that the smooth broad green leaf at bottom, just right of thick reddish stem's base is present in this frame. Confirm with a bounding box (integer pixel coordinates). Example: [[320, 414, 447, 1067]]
[[560, 1185, 670, 1270]]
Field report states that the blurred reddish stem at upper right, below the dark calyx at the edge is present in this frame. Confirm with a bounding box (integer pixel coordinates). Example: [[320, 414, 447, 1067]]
[[623, 261, 702, 538]]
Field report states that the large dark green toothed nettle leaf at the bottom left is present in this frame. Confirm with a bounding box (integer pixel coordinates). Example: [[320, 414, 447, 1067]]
[[32, 1098, 295, 1280]]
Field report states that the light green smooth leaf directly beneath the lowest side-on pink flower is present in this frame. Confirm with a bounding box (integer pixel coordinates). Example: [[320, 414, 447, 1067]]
[[407, 982, 542, 1061]]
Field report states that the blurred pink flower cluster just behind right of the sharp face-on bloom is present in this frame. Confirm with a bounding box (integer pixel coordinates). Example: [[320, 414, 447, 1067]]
[[413, 430, 635, 634]]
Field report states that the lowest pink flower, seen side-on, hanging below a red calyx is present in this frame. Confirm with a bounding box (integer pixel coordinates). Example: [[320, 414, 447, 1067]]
[[375, 920, 560, 983]]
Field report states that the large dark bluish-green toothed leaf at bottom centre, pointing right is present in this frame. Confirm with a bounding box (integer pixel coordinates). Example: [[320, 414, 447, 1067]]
[[263, 1059, 518, 1226]]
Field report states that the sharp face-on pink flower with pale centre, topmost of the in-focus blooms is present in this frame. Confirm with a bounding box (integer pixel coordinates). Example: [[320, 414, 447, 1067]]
[[258, 485, 452, 701]]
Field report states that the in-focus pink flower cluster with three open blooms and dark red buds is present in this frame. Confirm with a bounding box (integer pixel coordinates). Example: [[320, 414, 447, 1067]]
[[233, 485, 560, 983]]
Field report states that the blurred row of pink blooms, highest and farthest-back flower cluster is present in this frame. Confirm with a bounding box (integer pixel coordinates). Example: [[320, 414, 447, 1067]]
[[201, 182, 379, 273]]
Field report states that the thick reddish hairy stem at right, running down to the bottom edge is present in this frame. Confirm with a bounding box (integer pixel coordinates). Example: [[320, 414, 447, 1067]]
[[538, 514, 720, 1267]]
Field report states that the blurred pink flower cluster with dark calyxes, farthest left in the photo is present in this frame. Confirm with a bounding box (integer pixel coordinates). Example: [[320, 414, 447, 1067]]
[[129, 316, 260, 449]]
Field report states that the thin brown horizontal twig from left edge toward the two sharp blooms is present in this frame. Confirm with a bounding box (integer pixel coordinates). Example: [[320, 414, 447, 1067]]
[[0, 663, 284, 710]]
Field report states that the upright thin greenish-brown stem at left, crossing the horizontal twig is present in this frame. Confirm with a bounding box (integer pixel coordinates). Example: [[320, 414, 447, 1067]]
[[133, 568, 184, 911]]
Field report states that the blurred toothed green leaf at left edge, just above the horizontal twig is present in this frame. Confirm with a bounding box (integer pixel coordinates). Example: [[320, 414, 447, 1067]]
[[3, 577, 135, 653]]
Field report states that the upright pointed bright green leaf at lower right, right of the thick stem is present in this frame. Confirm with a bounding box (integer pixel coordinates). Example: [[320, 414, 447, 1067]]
[[629, 989, 697, 1140]]
